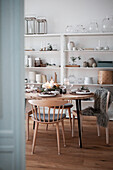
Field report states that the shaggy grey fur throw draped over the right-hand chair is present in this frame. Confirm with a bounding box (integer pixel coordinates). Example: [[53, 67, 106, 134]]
[[81, 88, 112, 127]]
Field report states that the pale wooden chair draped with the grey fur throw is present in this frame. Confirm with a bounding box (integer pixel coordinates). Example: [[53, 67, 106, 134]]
[[72, 91, 110, 144]]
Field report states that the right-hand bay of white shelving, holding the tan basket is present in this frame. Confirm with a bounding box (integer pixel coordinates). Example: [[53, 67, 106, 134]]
[[62, 32, 113, 89]]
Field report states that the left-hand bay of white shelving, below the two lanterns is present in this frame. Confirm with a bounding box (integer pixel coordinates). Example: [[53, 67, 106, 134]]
[[25, 34, 61, 85]]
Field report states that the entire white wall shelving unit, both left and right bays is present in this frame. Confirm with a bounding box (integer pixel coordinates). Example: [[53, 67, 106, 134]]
[[25, 32, 113, 87]]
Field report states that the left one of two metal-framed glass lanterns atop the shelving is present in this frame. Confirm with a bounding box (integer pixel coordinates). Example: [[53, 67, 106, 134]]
[[25, 17, 36, 34]]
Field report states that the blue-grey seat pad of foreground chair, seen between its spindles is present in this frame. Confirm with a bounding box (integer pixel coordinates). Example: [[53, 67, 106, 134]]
[[30, 113, 66, 122]]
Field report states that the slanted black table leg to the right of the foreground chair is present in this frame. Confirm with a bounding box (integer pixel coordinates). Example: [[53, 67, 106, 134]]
[[76, 99, 82, 148]]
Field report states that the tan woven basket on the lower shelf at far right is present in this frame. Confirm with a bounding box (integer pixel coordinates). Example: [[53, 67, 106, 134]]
[[98, 71, 113, 84]]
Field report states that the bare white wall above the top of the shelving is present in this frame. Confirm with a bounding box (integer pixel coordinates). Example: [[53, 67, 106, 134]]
[[25, 0, 113, 33]]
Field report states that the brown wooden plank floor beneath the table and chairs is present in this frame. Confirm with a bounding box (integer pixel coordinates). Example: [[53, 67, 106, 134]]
[[26, 117, 113, 170]]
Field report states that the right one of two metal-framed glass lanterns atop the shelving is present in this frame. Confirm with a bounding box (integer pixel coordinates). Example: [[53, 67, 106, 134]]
[[37, 17, 47, 34]]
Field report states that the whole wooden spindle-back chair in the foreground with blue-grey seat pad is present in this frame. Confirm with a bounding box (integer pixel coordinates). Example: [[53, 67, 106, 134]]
[[28, 100, 67, 155]]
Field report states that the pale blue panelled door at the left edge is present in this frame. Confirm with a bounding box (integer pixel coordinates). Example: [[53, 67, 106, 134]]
[[0, 0, 25, 170]]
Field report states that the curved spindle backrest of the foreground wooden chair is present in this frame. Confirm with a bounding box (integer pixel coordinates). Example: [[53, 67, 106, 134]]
[[28, 99, 67, 123]]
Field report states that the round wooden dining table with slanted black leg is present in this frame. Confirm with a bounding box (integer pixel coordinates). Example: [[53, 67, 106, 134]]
[[25, 93, 94, 148]]
